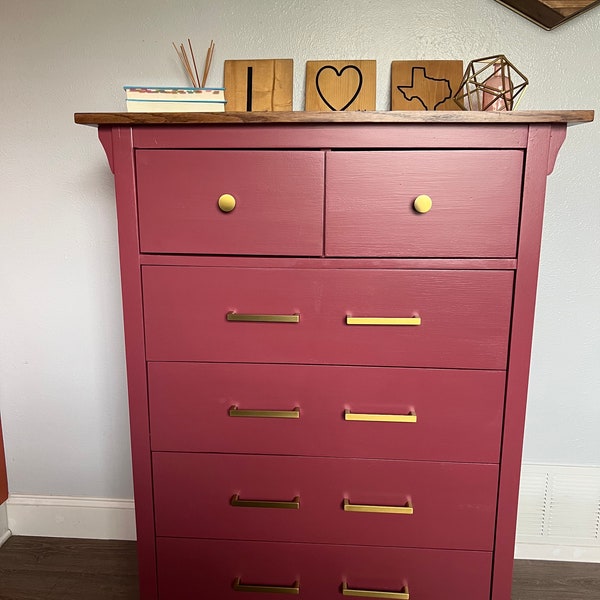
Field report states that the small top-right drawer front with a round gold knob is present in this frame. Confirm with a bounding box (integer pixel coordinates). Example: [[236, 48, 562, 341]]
[[325, 150, 523, 258]]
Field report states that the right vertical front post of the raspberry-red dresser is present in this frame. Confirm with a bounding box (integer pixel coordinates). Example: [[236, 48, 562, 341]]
[[492, 125, 551, 600]]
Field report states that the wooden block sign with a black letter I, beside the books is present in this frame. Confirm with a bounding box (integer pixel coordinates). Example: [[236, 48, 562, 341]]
[[224, 58, 294, 112]]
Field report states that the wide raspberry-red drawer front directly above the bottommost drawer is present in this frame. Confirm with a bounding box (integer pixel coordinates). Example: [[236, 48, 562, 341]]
[[153, 452, 498, 550]]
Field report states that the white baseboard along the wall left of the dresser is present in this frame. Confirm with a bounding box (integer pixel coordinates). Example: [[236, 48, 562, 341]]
[[6, 495, 136, 540]]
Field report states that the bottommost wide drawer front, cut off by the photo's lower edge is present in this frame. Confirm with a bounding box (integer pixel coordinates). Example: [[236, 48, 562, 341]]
[[157, 538, 491, 600]]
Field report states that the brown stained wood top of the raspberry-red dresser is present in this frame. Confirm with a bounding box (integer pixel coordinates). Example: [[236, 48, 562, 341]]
[[75, 110, 594, 126]]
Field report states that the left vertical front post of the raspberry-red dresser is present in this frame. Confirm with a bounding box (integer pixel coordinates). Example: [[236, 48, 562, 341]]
[[112, 127, 157, 600]]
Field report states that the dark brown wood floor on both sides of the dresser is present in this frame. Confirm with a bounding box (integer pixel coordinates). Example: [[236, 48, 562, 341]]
[[0, 537, 600, 600]]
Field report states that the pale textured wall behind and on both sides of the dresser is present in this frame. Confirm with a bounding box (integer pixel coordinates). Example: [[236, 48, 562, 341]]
[[0, 0, 600, 498]]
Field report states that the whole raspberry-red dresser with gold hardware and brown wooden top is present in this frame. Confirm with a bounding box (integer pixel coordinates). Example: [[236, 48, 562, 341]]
[[76, 111, 593, 600]]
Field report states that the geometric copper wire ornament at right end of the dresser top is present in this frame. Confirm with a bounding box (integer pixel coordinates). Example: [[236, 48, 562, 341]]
[[453, 54, 529, 111]]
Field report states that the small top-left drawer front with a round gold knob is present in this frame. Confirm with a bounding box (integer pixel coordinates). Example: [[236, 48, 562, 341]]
[[136, 150, 324, 256]]
